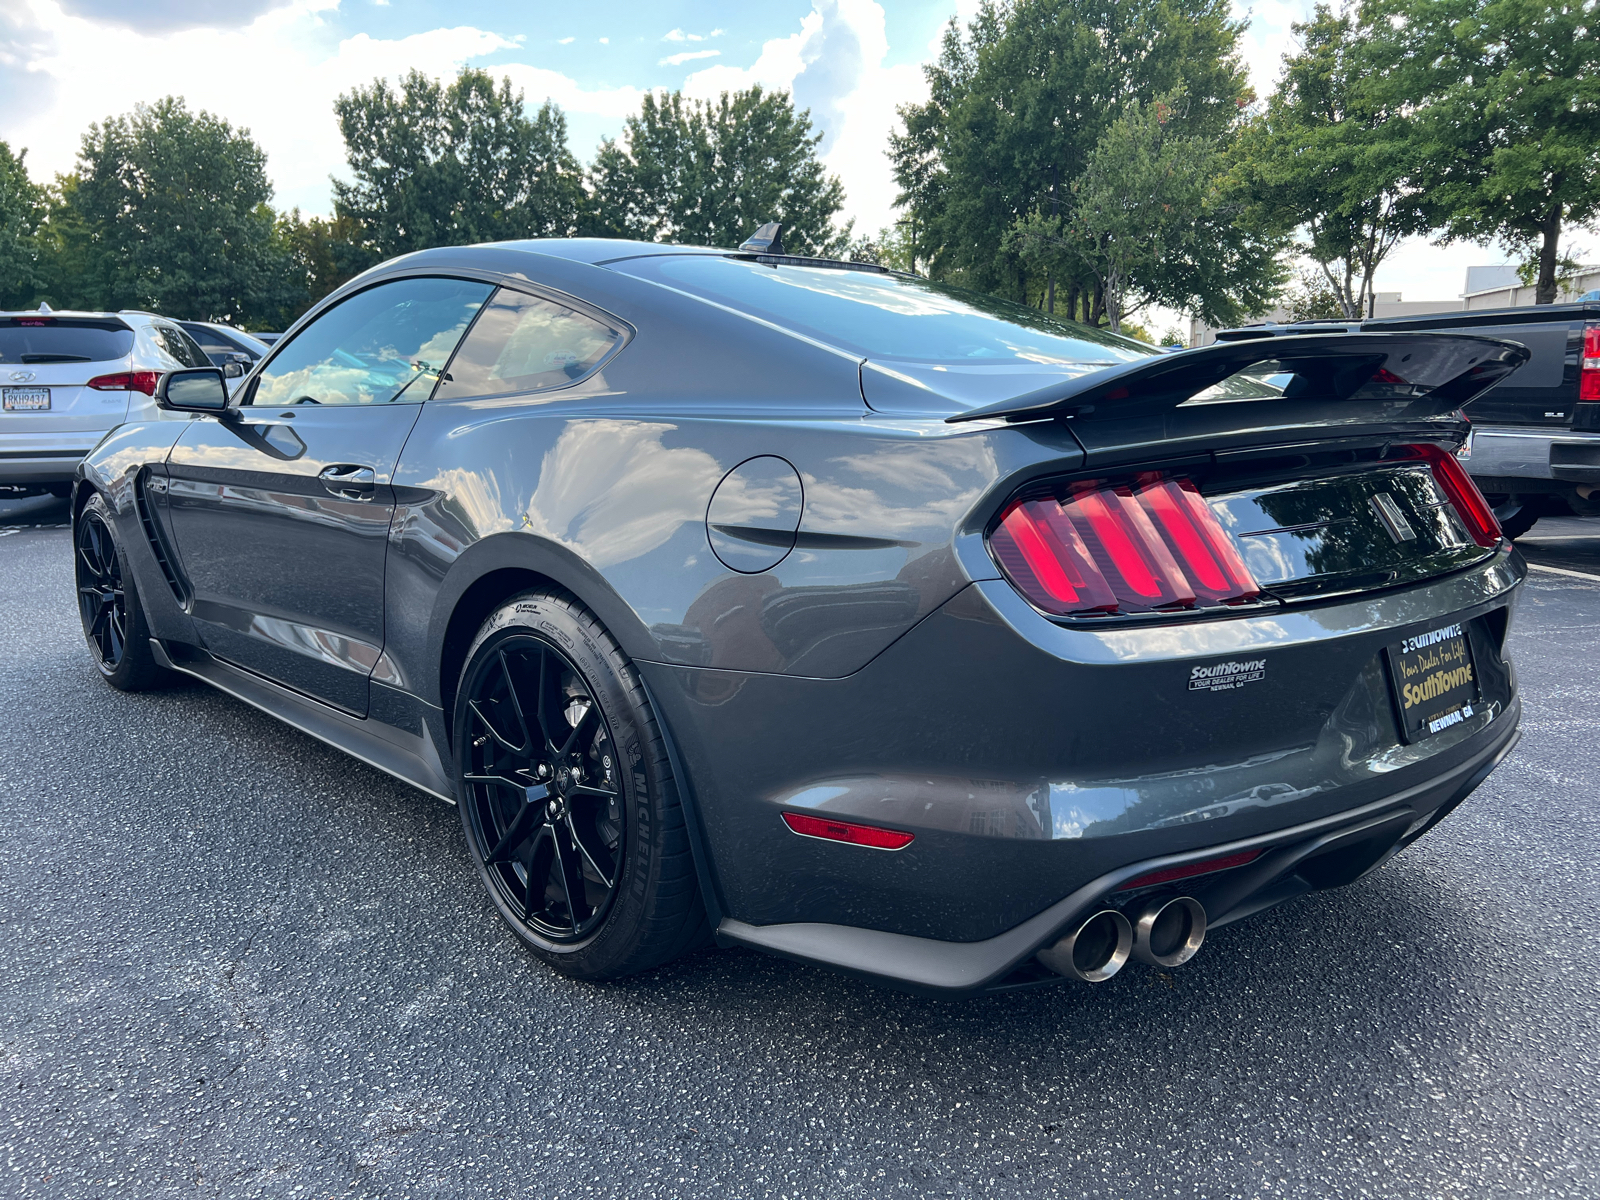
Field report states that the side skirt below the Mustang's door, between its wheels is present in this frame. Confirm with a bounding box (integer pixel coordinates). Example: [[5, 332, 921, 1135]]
[[150, 638, 456, 805]]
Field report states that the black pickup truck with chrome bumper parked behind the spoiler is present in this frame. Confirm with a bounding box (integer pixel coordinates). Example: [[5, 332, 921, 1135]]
[[1218, 301, 1600, 538]]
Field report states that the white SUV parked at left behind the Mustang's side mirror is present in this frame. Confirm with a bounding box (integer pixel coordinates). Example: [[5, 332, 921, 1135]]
[[0, 304, 211, 496]]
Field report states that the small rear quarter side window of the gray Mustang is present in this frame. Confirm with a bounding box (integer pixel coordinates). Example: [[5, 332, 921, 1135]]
[[434, 290, 622, 400]]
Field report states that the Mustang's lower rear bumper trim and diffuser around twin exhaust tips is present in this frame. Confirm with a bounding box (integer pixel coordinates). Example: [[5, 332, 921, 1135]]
[[717, 701, 1520, 997]]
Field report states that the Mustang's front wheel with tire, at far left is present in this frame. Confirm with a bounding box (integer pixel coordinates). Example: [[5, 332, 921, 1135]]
[[72, 494, 168, 691]]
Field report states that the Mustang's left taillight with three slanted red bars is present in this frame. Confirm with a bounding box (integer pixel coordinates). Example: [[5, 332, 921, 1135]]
[[989, 472, 1261, 616]]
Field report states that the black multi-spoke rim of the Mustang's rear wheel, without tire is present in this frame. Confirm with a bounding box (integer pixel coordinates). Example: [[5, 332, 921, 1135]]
[[461, 634, 624, 944]]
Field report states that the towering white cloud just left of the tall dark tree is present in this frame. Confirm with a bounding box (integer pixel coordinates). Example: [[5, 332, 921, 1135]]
[[683, 0, 928, 234]]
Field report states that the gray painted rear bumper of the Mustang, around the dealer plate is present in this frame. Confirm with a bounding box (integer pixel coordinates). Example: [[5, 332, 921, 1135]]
[[638, 547, 1525, 987]]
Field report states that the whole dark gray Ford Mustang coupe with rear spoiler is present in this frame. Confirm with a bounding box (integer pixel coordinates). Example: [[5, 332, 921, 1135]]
[[74, 240, 1526, 994]]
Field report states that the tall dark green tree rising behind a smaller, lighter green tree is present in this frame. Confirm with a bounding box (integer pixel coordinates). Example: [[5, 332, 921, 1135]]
[[890, 0, 1251, 312]]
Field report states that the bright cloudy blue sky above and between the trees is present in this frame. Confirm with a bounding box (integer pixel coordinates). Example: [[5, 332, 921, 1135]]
[[0, 0, 1501, 307]]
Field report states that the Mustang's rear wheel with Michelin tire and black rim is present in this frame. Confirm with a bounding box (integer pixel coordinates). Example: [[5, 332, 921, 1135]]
[[454, 592, 707, 979]]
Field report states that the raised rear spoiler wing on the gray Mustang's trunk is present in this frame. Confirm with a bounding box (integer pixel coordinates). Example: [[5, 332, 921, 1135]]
[[946, 333, 1530, 424]]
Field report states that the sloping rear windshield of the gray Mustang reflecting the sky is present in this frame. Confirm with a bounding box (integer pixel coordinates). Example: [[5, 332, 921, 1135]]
[[611, 254, 1155, 365]]
